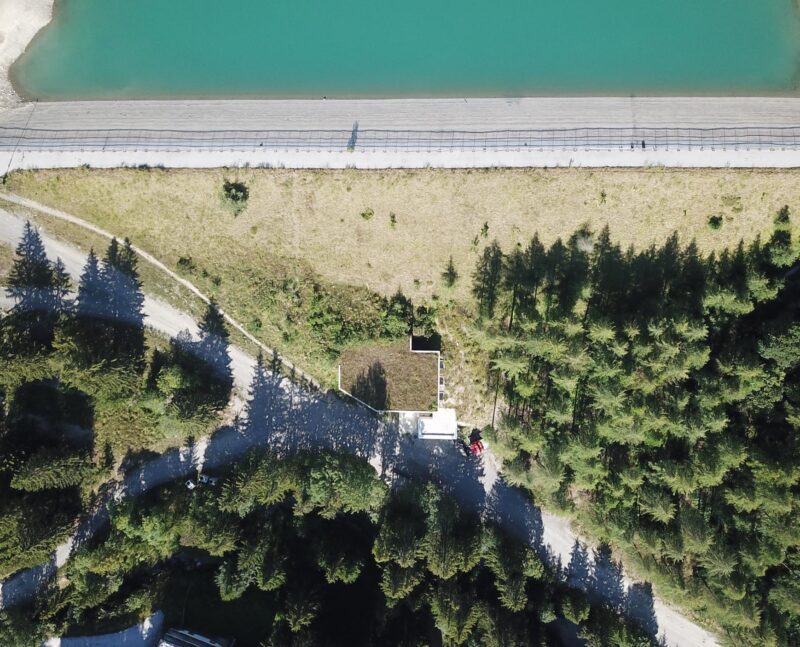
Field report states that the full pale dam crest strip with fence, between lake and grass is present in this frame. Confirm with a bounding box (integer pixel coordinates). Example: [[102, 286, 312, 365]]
[[0, 97, 800, 172]]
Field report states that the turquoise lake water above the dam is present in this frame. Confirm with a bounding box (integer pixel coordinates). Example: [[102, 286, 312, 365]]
[[13, 0, 800, 99]]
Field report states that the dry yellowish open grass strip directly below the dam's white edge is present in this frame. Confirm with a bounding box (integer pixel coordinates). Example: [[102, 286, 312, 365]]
[[8, 169, 800, 298]]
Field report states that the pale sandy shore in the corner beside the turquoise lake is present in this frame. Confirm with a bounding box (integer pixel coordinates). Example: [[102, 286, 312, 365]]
[[0, 0, 53, 112]]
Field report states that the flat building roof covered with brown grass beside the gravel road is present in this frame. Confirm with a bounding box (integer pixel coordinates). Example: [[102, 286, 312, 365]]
[[340, 340, 439, 411]]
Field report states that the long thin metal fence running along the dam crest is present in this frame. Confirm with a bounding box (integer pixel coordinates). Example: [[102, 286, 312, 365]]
[[0, 123, 800, 152]]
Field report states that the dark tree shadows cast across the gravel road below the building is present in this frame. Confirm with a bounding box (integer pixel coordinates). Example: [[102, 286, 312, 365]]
[[3, 354, 658, 647]]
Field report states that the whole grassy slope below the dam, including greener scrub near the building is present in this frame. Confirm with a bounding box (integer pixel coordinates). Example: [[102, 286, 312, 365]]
[[6, 169, 800, 412]]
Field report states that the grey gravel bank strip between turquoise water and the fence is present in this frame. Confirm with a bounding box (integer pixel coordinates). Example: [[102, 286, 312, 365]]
[[0, 97, 800, 131]]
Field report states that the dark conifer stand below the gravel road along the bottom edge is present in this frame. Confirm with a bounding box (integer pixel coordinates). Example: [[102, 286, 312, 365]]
[[0, 442, 654, 647]]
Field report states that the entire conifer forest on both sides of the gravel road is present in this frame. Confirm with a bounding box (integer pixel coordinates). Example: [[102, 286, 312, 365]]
[[0, 209, 800, 647]]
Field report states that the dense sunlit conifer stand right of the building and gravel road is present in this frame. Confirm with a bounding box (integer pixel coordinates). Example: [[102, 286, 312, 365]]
[[472, 208, 800, 645]]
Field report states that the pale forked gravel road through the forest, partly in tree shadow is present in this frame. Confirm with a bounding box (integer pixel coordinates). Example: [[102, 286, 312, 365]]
[[0, 208, 718, 647]]
